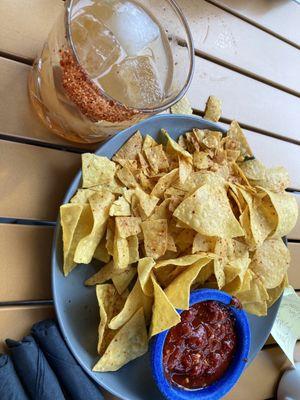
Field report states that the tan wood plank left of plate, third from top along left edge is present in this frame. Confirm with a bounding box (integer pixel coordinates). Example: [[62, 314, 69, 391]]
[[0, 140, 81, 221]]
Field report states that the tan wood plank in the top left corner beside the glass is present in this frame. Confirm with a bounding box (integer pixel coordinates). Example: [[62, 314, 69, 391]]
[[0, 0, 63, 59]]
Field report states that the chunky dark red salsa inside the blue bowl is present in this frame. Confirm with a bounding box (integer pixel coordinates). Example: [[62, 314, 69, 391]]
[[163, 301, 237, 389]]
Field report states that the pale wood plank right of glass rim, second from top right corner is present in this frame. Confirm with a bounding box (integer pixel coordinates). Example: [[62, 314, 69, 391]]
[[178, 0, 300, 93]]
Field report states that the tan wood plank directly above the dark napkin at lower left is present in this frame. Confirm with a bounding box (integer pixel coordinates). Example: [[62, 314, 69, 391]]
[[0, 306, 55, 353]]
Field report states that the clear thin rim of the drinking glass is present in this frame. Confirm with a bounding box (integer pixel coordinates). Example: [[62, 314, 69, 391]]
[[64, 0, 195, 114]]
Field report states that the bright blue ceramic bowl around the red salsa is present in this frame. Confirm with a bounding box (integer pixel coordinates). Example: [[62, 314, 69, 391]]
[[151, 289, 250, 400]]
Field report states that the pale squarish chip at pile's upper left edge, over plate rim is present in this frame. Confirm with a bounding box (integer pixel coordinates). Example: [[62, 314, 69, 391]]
[[81, 153, 116, 188]]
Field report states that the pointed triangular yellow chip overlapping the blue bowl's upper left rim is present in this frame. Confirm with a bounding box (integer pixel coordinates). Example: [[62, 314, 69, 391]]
[[149, 274, 180, 337]]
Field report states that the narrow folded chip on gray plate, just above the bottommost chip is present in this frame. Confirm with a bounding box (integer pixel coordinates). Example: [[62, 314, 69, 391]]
[[96, 284, 125, 355]]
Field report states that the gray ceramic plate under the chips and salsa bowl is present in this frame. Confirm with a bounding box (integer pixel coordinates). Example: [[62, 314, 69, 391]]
[[52, 115, 280, 400]]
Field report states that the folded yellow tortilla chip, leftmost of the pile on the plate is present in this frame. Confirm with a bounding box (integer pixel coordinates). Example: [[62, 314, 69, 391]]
[[60, 204, 93, 276]]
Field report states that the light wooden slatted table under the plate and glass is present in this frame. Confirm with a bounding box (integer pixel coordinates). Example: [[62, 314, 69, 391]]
[[0, 0, 300, 400]]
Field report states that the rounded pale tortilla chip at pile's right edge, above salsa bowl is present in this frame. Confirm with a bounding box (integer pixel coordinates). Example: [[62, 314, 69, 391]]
[[250, 238, 291, 289]]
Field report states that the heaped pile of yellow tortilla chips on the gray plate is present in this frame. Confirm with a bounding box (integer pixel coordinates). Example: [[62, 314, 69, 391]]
[[60, 97, 297, 371]]
